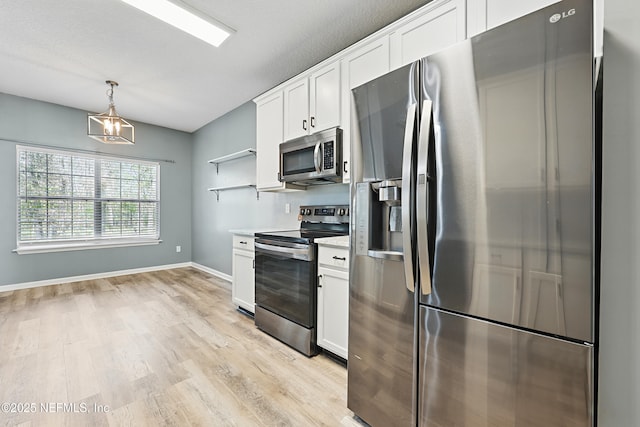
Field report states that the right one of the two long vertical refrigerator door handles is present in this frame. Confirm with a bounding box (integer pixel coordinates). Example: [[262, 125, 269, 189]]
[[416, 100, 433, 295]]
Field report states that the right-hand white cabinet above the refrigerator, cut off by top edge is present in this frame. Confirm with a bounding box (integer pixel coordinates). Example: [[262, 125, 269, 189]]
[[467, 0, 559, 37]]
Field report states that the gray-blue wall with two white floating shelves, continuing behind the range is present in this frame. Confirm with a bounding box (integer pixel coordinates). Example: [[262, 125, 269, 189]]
[[192, 102, 349, 275]]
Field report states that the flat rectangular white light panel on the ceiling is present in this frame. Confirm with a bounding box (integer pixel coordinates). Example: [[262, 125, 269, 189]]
[[122, 0, 233, 47]]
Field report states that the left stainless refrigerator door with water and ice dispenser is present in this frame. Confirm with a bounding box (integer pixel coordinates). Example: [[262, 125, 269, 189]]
[[347, 63, 419, 426]]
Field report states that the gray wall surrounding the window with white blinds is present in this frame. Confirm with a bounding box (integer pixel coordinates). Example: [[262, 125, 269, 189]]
[[0, 93, 191, 286]]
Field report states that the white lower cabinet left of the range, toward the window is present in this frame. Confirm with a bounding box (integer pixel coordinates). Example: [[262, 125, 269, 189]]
[[231, 235, 255, 313]]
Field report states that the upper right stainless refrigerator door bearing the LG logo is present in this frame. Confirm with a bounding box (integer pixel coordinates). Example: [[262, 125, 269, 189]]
[[421, 0, 595, 342]]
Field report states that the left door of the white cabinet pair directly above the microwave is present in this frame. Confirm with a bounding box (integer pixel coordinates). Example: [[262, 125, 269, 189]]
[[283, 77, 309, 141]]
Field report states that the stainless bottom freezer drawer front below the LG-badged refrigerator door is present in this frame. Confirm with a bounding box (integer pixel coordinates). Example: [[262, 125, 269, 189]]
[[418, 306, 594, 427]]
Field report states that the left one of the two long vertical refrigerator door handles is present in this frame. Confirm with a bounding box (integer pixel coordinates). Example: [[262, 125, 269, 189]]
[[401, 103, 417, 292]]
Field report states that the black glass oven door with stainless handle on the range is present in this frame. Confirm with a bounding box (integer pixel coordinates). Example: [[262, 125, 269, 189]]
[[255, 239, 317, 328]]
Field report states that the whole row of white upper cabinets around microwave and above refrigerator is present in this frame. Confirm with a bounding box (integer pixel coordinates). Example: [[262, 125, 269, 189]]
[[254, 0, 536, 191]]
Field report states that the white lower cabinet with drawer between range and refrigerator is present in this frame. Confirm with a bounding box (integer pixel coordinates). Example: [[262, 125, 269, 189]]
[[317, 244, 349, 360]]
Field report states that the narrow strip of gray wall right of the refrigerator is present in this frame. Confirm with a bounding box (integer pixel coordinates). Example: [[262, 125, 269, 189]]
[[598, 0, 640, 427]]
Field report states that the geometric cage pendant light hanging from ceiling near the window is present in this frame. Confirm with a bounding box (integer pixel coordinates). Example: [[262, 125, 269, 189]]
[[87, 80, 135, 144]]
